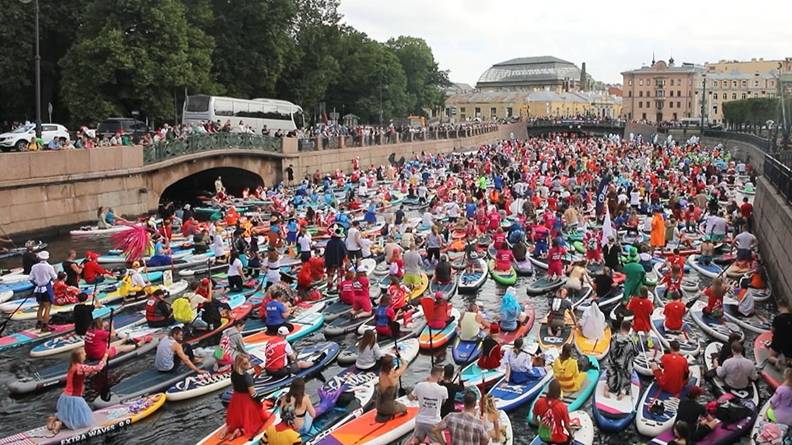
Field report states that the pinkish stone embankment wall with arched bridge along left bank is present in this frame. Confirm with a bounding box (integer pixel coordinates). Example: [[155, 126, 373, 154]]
[[0, 119, 527, 236]]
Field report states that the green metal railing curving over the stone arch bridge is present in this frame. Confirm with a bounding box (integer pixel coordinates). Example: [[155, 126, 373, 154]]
[[143, 133, 283, 164]]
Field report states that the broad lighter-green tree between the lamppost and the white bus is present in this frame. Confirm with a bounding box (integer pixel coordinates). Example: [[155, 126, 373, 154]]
[[62, 0, 215, 123]]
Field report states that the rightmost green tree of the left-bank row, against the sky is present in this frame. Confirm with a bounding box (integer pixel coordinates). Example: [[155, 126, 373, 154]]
[[386, 36, 450, 115]]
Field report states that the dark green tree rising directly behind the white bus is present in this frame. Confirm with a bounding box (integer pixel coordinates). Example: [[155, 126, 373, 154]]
[[205, 0, 296, 99]]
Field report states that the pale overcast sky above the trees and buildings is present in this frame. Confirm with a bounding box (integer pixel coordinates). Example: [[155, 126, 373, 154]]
[[341, 0, 792, 85]]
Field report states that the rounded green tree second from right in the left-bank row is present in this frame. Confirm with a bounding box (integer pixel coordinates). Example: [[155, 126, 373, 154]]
[[326, 28, 409, 124]]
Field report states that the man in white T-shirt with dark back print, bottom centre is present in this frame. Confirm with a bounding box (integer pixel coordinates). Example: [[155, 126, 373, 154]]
[[409, 367, 448, 443]]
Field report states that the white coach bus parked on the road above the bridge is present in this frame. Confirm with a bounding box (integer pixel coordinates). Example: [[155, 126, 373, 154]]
[[182, 94, 303, 133]]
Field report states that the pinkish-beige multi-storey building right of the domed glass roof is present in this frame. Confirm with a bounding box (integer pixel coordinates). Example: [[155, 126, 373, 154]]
[[621, 59, 703, 123]]
